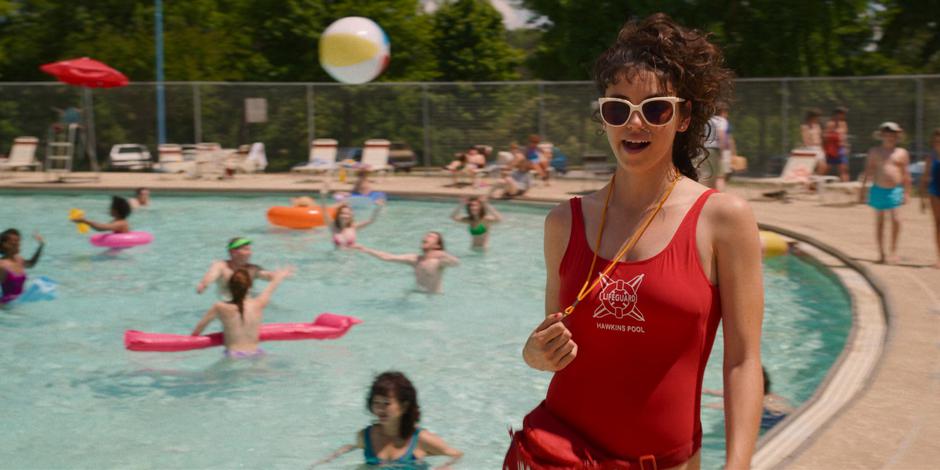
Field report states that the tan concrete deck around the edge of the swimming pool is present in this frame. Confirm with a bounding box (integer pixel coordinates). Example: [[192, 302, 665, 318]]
[[0, 173, 940, 469]]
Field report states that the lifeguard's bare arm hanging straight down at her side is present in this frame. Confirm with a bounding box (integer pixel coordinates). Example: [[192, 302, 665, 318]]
[[710, 194, 764, 469]]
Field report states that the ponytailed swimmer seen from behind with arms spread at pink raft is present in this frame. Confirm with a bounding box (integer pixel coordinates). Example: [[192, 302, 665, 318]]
[[192, 267, 294, 358]]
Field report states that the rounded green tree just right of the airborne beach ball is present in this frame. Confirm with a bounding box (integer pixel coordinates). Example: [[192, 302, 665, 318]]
[[433, 0, 522, 81]]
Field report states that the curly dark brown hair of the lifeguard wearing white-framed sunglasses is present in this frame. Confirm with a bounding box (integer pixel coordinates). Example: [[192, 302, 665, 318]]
[[594, 13, 734, 180]]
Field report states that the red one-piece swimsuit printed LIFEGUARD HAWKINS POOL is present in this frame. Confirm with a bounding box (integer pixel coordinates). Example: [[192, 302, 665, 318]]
[[545, 190, 721, 468]]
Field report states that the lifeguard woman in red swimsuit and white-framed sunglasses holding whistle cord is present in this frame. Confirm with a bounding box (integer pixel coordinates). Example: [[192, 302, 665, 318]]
[[504, 14, 764, 470]]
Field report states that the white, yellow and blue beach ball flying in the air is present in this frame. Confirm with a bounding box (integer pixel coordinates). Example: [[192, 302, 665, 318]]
[[320, 16, 390, 83]]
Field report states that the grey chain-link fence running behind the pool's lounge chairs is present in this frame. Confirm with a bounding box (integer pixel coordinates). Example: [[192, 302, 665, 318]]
[[0, 75, 940, 175]]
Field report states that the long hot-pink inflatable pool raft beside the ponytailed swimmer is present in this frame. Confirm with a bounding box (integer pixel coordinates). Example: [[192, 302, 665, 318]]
[[124, 313, 362, 352]]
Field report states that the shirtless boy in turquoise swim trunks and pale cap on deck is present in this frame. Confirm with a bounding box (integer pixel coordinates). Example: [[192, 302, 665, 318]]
[[858, 121, 911, 264]]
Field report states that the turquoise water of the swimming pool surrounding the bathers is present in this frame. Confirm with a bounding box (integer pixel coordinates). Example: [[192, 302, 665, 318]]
[[0, 193, 851, 469]]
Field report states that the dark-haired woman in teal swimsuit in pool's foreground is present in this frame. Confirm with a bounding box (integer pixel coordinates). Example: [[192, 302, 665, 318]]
[[313, 371, 463, 469]]
